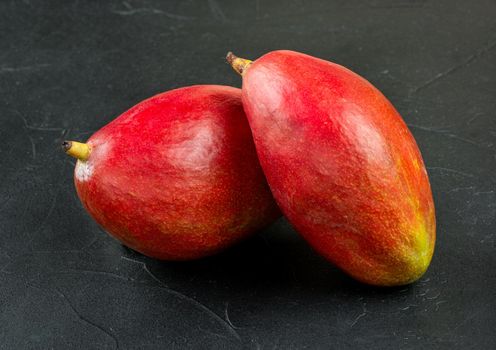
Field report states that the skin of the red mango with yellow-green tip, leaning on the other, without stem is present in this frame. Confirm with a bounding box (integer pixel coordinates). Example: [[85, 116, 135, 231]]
[[236, 51, 436, 286]]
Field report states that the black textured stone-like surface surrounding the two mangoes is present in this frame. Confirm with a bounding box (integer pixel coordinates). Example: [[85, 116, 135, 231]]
[[0, 0, 496, 349]]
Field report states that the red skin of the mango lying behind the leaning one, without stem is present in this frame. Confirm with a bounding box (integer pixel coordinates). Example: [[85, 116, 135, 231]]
[[75, 85, 280, 260]]
